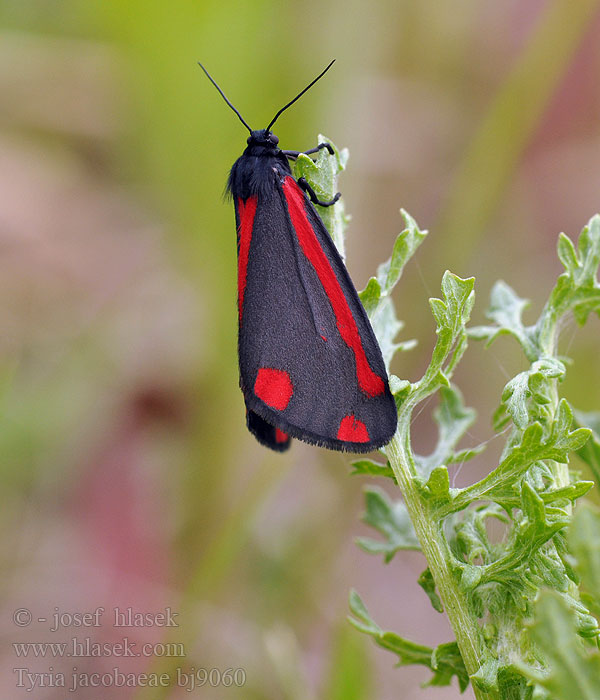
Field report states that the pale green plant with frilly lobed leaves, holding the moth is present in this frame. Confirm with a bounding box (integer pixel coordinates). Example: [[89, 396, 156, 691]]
[[296, 136, 600, 700]]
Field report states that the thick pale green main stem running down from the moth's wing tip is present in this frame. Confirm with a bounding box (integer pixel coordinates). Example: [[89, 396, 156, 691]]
[[386, 424, 496, 700]]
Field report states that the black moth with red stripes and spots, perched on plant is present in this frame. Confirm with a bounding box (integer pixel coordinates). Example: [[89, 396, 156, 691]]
[[199, 61, 397, 452]]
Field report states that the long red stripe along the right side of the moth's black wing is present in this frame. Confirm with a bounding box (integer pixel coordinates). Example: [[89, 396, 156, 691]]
[[283, 177, 385, 396]]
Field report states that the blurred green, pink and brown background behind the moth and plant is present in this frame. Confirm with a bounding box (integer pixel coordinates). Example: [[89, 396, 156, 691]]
[[0, 0, 600, 700]]
